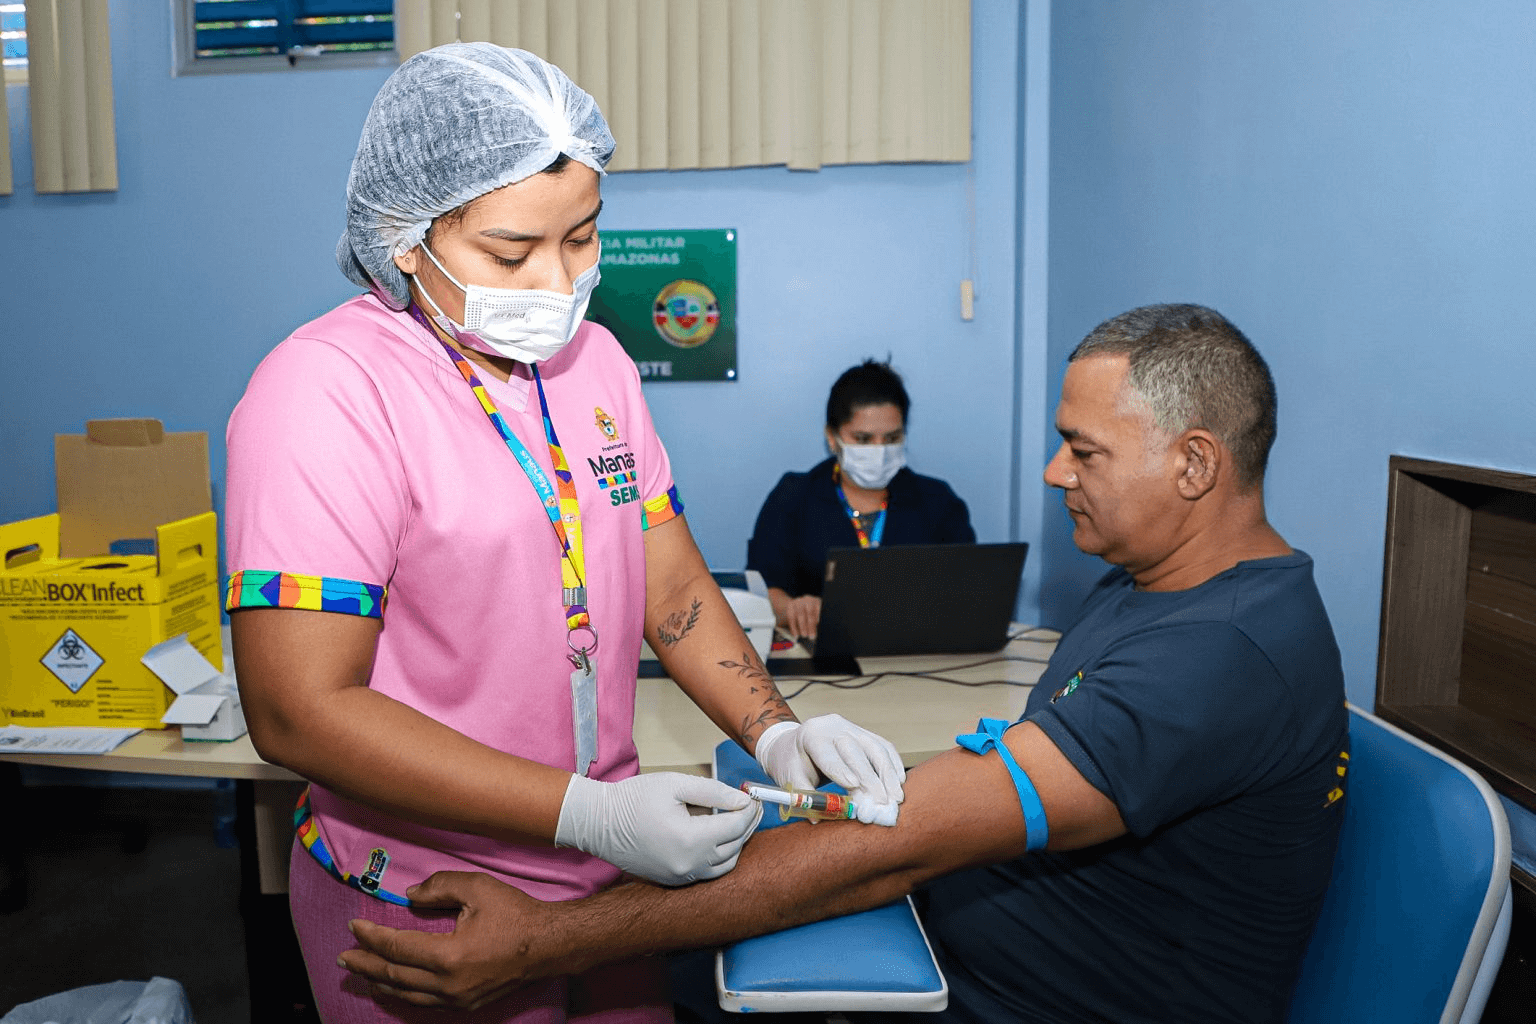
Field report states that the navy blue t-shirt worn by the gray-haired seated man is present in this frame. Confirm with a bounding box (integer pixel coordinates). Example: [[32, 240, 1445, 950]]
[[923, 551, 1349, 1024]]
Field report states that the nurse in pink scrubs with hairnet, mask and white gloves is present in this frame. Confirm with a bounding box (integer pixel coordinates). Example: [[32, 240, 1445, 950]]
[[226, 43, 903, 1022]]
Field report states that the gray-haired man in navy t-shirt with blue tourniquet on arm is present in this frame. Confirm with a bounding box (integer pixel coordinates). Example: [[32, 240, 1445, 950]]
[[344, 306, 1349, 1022]]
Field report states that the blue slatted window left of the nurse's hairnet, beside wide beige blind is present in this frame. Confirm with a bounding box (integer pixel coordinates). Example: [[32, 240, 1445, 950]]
[[194, 0, 395, 60]]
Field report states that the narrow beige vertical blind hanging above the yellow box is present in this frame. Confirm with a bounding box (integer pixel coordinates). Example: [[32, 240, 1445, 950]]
[[26, 0, 117, 192]]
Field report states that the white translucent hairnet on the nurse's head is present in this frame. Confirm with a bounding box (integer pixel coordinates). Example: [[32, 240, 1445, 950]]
[[336, 43, 613, 309]]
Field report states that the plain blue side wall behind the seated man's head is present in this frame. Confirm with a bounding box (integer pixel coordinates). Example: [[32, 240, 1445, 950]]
[[1040, 0, 1536, 706]]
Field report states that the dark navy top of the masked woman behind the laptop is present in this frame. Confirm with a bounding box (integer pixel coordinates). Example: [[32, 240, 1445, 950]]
[[746, 459, 975, 597]]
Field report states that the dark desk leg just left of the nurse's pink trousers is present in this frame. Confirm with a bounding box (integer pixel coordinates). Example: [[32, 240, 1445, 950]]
[[235, 778, 319, 1024]]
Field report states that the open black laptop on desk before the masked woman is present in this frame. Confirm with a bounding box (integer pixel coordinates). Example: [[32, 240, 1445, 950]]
[[780, 542, 1029, 676]]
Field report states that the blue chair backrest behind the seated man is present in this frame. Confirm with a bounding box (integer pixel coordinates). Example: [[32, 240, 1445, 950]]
[[1290, 706, 1510, 1024]]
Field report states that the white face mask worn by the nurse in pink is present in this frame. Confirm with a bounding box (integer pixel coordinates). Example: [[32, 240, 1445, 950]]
[[421, 243, 602, 362]]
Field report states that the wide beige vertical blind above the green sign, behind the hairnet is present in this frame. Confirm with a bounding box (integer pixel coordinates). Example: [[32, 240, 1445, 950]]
[[395, 0, 971, 170]]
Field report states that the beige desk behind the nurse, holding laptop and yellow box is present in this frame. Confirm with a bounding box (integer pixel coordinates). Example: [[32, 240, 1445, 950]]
[[0, 626, 1058, 895]]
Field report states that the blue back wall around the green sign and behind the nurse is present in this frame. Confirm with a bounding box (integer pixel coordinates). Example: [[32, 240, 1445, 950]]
[[0, 0, 1044, 620]]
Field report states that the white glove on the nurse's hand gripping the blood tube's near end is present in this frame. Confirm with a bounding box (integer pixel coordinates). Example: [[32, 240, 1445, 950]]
[[554, 772, 763, 886]]
